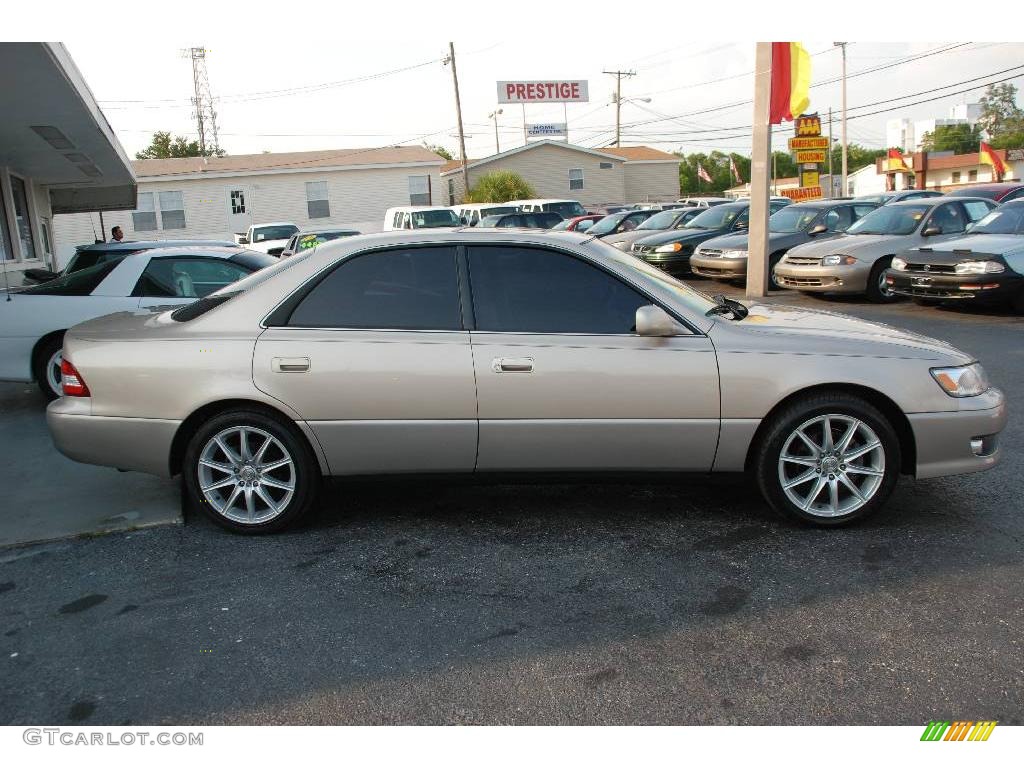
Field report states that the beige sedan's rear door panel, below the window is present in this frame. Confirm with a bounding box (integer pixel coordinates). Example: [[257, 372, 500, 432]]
[[253, 328, 477, 475]]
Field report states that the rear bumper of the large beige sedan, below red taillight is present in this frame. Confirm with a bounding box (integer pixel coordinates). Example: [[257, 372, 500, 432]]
[[46, 397, 181, 477]]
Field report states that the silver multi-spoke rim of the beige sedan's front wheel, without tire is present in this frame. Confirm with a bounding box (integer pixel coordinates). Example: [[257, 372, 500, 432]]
[[778, 414, 886, 517]]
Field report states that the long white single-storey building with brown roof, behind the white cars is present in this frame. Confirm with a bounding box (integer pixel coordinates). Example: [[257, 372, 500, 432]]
[[54, 146, 444, 263]]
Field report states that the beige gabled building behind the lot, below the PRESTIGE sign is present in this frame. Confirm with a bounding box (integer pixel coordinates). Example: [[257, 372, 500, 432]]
[[441, 139, 680, 206]]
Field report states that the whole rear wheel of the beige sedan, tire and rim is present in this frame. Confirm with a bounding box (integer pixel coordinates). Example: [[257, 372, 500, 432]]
[[183, 411, 321, 534]]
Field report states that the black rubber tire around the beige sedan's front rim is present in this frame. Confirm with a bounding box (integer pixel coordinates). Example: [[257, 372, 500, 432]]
[[753, 392, 901, 527]]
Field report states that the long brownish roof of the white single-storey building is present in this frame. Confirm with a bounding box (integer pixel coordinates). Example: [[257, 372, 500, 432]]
[[132, 146, 444, 178]]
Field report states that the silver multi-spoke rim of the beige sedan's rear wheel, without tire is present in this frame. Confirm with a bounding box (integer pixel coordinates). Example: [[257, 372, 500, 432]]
[[198, 427, 296, 525]]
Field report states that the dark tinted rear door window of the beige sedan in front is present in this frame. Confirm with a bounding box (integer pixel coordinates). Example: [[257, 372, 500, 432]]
[[288, 248, 462, 331]]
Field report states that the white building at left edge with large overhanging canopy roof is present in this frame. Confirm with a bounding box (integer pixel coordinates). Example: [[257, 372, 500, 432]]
[[0, 43, 135, 285]]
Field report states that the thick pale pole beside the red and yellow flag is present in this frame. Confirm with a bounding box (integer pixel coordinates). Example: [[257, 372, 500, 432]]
[[746, 43, 771, 298]]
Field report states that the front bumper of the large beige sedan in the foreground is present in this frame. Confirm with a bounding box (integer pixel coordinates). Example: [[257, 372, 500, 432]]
[[907, 389, 1007, 478]]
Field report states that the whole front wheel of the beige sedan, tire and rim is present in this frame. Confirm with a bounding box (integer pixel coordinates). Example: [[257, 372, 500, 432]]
[[757, 393, 900, 525]]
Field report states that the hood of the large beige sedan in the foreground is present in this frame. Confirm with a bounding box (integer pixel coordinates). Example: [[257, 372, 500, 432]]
[[723, 304, 974, 366]]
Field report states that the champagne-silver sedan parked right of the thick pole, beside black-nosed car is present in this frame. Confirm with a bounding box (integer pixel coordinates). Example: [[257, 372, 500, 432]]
[[772, 198, 996, 303]]
